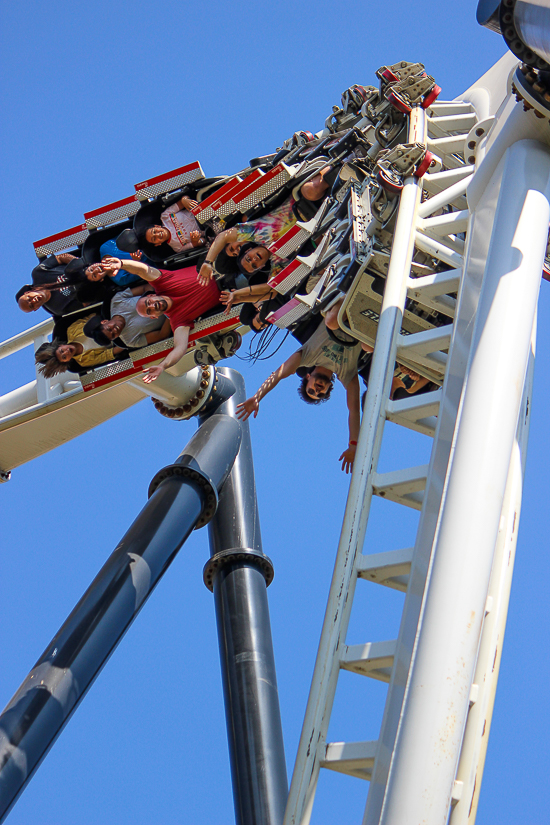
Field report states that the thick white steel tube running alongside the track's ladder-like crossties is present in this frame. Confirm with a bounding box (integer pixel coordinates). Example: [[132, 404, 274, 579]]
[[365, 132, 550, 825]]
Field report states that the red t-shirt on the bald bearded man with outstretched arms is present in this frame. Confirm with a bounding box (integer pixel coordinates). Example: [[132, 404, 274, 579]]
[[152, 266, 220, 332]]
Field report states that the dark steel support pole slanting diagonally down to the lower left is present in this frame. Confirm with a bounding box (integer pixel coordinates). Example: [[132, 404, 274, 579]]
[[0, 408, 242, 821]]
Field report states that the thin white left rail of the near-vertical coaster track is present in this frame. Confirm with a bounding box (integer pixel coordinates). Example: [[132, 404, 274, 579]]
[[285, 109, 426, 825]]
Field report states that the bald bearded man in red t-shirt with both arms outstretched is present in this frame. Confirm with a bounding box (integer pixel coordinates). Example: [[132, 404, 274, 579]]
[[102, 258, 220, 384]]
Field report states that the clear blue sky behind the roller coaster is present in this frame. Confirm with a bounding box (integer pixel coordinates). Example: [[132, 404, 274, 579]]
[[0, 0, 550, 825]]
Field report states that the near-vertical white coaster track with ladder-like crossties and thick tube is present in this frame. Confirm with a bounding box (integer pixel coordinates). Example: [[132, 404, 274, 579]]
[[285, 87, 548, 825]]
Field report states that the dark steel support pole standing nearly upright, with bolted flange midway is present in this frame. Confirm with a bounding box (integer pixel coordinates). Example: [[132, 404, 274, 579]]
[[204, 369, 288, 825]]
